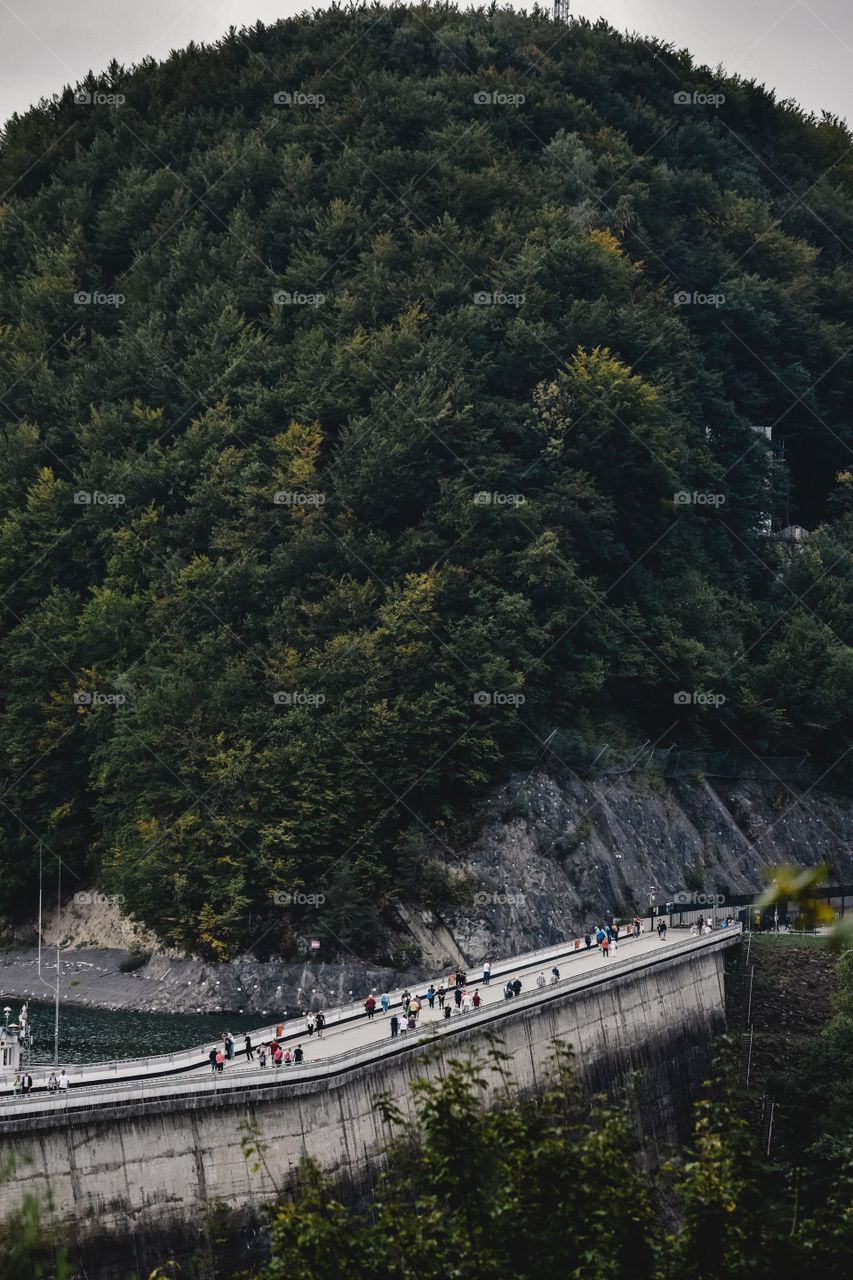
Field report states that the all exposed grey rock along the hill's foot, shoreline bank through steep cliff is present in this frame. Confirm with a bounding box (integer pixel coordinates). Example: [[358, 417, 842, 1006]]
[[0, 773, 853, 1014]]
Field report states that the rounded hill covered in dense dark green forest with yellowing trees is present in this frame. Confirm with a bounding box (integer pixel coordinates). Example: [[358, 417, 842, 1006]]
[[0, 4, 853, 956]]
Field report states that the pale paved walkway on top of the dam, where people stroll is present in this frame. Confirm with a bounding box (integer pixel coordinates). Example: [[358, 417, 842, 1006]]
[[0, 927, 740, 1119]]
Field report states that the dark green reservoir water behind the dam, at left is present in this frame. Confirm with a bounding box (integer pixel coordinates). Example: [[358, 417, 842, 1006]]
[[23, 1001, 261, 1064]]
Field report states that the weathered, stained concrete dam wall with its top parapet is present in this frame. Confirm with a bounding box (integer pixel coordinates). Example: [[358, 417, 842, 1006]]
[[0, 927, 740, 1277]]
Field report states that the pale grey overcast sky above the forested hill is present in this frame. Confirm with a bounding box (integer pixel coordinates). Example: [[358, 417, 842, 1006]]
[[0, 0, 853, 120]]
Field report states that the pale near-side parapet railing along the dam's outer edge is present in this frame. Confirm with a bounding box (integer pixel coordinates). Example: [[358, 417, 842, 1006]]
[[0, 925, 742, 1128]]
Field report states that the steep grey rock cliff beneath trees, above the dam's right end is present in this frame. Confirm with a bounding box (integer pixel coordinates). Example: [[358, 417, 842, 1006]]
[[399, 773, 853, 961]]
